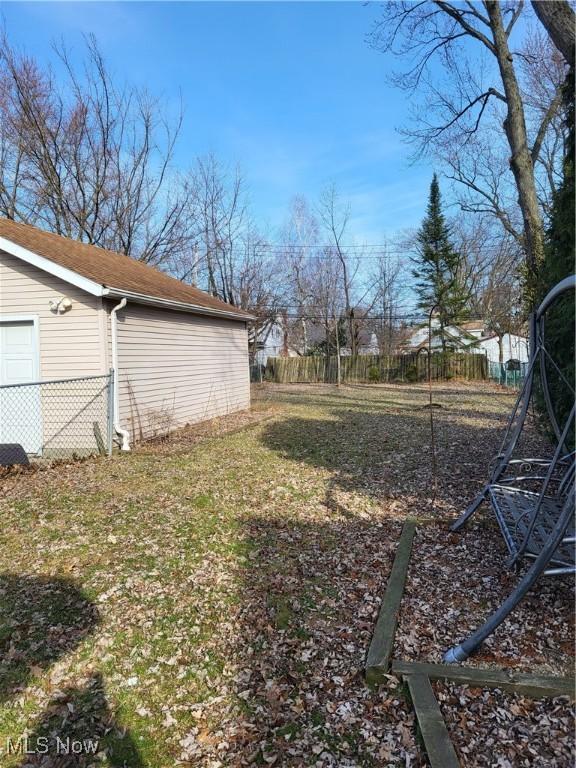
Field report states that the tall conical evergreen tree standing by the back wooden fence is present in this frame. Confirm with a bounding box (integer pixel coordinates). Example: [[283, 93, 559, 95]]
[[412, 174, 469, 352]]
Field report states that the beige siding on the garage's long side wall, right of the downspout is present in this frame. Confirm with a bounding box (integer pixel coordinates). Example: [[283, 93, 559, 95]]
[[113, 303, 250, 440]]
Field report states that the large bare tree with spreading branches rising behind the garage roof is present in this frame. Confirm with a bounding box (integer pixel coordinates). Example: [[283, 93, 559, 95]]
[[0, 33, 196, 264]]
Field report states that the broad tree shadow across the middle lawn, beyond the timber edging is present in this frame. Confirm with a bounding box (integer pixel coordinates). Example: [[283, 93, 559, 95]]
[[261, 407, 501, 515]]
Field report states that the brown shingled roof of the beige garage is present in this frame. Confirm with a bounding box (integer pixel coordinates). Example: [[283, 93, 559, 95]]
[[0, 218, 251, 320]]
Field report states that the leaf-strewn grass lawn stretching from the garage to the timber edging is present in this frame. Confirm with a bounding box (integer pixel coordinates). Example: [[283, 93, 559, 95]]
[[0, 385, 568, 768]]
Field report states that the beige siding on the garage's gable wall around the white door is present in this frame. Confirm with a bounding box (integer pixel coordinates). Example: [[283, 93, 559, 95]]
[[0, 251, 108, 457]]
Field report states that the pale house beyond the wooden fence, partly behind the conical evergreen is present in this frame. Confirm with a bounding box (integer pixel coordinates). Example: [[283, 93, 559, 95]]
[[399, 317, 528, 363]]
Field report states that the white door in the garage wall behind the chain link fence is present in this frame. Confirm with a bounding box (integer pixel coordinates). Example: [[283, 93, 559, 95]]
[[0, 320, 42, 454]]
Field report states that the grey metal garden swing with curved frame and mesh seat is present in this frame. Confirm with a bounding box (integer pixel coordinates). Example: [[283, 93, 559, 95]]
[[444, 275, 576, 663]]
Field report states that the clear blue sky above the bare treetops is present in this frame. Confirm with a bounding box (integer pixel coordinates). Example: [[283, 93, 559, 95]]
[[0, 2, 432, 243]]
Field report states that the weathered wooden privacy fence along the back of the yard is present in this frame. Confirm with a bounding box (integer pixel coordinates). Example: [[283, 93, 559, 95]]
[[264, 352, 488, 384]]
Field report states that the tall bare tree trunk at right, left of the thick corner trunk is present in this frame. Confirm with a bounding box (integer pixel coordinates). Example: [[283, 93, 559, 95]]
[[485, 0, 544, 296]]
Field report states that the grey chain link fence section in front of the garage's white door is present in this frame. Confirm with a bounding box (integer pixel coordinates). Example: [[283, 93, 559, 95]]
[[0, 373, 113, 459]]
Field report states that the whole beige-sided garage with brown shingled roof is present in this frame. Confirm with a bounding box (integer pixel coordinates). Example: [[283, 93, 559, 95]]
[[0, 219, 251, 455]]
